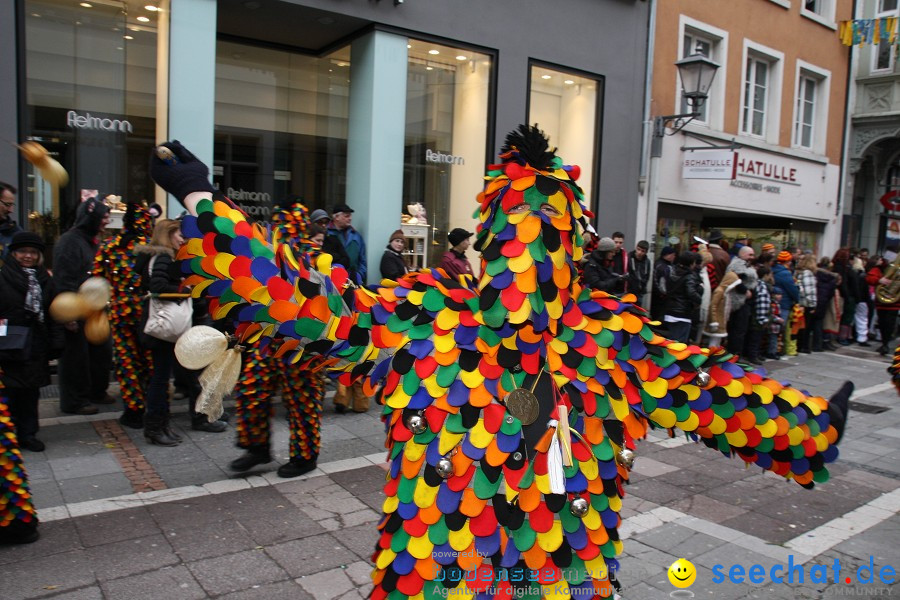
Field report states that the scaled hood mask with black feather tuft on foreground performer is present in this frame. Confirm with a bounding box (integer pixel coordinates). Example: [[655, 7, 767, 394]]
[[475, 125, 588, 331]]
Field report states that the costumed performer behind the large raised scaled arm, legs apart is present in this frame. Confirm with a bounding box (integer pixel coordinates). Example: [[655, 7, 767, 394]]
[[229, 204, 325, 477]]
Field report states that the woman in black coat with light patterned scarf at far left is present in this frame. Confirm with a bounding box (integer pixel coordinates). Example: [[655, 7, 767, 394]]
[[0, 231, 62, 452]]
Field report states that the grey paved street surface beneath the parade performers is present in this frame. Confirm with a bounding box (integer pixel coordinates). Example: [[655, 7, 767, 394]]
[[0, 346, 900, 600]]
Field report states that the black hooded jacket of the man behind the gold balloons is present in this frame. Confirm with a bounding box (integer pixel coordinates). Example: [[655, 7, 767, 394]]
[[53, 198, 109, 292]]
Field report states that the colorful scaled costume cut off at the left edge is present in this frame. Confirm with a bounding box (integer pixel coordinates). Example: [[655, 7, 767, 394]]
[[0, 383, 38, 544]]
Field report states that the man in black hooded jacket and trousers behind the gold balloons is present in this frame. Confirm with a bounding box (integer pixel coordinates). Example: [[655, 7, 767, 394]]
[[53, 198, 113, 415]]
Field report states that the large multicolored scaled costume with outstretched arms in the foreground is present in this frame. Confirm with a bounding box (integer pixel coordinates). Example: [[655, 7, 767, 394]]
[[152, 126, 852, 600]]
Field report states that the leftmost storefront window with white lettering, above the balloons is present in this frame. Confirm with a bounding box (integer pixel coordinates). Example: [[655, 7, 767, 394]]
[[20, 0, 159, 240]]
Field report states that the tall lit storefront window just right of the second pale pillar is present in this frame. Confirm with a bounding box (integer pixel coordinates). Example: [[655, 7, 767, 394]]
[[403, 39, 492, 266]]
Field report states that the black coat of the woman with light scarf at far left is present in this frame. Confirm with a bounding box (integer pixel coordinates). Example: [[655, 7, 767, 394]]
[[0, 258, 63, 389]]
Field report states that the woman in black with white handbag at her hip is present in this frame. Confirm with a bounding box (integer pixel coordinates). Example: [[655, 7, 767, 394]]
[[134, 219, 193, 446]]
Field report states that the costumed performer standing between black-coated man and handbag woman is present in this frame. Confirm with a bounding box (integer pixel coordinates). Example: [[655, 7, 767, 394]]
[[94, 202, 153, 429]]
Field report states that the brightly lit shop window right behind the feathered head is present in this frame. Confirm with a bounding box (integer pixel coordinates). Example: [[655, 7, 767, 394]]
[[528, 64, 603, 208]]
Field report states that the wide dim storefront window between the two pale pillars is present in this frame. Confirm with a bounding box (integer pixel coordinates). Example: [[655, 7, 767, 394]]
[[213, 41, 350, 220]]
